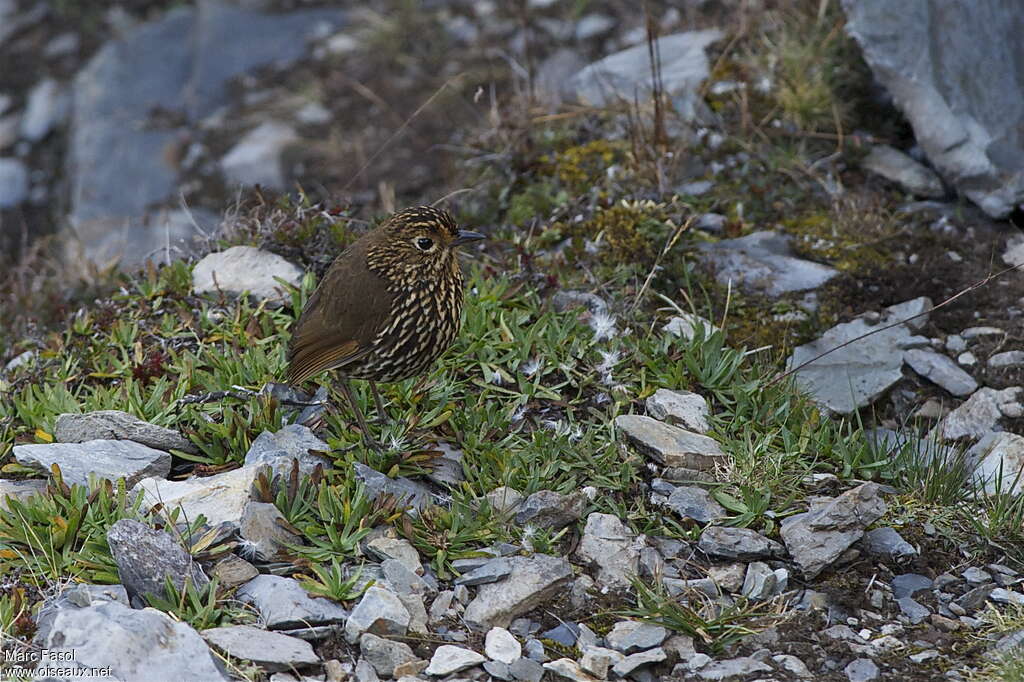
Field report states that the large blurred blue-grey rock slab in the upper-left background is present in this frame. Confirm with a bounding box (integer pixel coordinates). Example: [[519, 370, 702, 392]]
[[67, 0, 344, 264]]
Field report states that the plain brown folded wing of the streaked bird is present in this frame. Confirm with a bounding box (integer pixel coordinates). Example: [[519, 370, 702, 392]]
[[288, 235, 391, 386]]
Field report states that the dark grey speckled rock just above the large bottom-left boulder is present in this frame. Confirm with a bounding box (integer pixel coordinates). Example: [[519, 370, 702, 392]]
[[106, 518, 210, 604]]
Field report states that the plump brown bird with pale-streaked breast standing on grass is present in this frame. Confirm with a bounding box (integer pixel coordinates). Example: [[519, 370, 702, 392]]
[[287, 206, 485, 444]]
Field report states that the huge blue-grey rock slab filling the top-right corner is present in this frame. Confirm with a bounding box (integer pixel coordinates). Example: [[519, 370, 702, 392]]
[[843, 0, 1024, 218]]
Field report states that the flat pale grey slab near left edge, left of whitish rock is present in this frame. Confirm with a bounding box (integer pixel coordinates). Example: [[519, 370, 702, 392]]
[[14, 439, 171, 487]]
